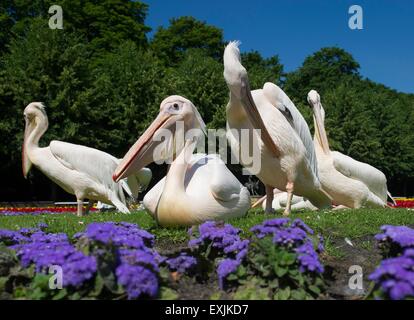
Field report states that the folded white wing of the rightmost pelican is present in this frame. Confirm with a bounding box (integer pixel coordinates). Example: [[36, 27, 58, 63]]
[[331, 151, 387, 202]]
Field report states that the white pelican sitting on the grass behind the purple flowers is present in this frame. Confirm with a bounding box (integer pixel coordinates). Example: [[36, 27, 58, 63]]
[[113, 96, 250, 226]]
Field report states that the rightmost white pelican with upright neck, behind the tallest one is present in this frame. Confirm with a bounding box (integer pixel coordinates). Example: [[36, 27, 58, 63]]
[[308, 90, 392, 208]]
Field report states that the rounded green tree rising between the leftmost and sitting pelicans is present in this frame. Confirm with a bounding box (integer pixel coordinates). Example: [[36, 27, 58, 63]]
[[74, 42, 167, 157]]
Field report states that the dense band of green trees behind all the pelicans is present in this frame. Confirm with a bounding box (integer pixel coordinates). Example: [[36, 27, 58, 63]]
[[0, 0, 414, 200]]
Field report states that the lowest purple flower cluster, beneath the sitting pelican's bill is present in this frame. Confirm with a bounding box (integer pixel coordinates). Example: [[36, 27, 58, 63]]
[[116, 264, 158, 299]]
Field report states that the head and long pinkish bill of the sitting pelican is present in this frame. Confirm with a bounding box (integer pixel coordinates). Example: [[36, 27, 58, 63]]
[[112, 95, 206, 182]]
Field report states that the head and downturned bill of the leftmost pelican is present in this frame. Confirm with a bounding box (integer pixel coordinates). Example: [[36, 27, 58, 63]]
[[22, 102, 48, 178]]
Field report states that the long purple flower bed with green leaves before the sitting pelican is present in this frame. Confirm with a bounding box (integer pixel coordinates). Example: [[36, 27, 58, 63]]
[[0, 219, 324, 299]]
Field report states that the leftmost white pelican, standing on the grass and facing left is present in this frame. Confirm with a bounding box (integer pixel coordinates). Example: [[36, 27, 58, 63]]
[[22, 102, 151, 216]]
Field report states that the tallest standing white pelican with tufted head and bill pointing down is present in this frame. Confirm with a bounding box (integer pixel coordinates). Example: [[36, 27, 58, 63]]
[[224, 42, 331, 215]]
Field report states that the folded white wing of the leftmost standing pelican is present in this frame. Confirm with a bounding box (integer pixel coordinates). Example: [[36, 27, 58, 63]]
[[50, 140, 119, 190]]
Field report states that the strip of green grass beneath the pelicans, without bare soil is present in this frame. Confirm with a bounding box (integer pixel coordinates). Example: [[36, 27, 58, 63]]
[[0, 209, 414, 258]]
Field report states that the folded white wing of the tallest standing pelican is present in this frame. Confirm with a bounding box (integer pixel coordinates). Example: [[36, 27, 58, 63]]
[[263, 82, 318, 177]]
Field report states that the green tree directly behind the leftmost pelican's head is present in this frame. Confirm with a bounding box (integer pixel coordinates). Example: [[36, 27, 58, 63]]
[[0, 18, 89, 197]]
